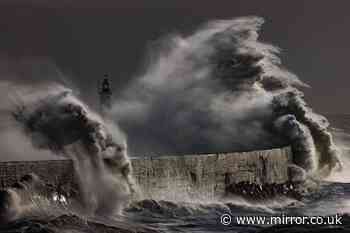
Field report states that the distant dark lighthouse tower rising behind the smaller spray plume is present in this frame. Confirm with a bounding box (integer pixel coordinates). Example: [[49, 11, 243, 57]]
[[98, 75, 112, 116]]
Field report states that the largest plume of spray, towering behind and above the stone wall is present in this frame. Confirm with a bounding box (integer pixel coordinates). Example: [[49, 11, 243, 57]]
[[112, 17, 340, 175]]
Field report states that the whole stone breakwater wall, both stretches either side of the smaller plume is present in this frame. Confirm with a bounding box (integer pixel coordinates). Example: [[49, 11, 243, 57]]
[[0, 147, 292, 200]]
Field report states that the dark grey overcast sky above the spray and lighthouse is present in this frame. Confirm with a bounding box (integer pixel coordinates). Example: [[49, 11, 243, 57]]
[[0, 0, 350, 113]]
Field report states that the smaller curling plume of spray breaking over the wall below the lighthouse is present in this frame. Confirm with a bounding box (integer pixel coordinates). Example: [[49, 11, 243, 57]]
[[13, 87, 133, 215]]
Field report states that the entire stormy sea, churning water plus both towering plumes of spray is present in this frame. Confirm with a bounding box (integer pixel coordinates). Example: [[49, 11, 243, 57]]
[[0, 17, 350, 233]]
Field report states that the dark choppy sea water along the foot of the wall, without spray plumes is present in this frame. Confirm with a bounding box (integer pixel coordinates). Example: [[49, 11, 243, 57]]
[[0, 115, 350, 233]]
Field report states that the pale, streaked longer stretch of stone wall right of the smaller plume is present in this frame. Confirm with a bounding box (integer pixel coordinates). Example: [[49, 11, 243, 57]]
[[132, 148, 291, 200]]
